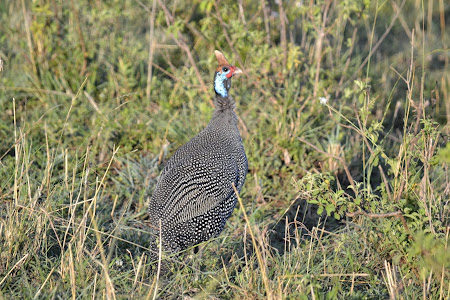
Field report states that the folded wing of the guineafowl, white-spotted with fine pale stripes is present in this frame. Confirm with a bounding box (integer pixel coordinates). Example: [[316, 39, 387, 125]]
[[152, 153, 238, 225]]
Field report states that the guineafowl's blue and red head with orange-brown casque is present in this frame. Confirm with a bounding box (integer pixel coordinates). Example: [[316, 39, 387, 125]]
[[214, 50, 242, 98]]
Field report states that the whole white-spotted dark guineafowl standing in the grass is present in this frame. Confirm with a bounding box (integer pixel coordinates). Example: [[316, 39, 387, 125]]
[[148, 50, 248, 264]]
